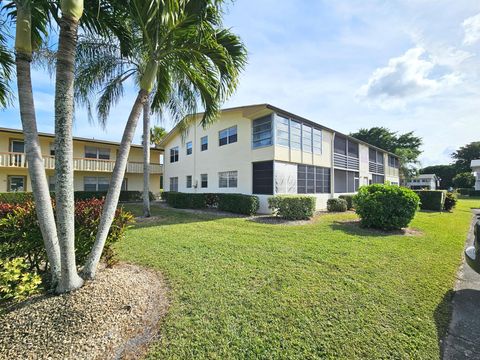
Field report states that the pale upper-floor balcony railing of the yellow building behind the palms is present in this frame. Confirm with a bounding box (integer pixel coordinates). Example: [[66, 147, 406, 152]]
[[0, 153, 163, 174]]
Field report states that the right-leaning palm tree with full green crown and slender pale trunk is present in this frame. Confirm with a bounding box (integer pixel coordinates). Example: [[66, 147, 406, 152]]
[[78, 0, 246, 278]]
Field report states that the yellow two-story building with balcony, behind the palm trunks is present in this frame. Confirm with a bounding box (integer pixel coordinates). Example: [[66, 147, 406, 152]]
[[0, 128, 162, 194]]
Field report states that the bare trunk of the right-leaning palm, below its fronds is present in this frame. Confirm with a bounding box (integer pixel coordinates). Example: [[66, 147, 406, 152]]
[[82, 89, 148, 279]]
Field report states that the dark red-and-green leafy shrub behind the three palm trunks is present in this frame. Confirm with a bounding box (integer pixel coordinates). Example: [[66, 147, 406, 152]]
[[0, 199, 133, 272]]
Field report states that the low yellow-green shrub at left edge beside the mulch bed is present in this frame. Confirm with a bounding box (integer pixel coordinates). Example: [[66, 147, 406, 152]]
[[0, 258, 42, 301]]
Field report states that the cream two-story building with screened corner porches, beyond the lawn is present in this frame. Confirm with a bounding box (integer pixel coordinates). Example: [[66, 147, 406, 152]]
[[160, 104, 400, 213]]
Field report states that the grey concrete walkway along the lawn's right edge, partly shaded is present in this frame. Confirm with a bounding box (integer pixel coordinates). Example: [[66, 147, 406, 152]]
[[443, 210, 480, 360]]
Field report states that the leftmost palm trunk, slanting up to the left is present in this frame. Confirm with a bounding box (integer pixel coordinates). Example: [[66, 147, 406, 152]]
[[15, 3, 60, 286]]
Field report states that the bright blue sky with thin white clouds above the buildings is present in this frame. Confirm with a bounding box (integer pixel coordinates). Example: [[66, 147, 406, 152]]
[[0, 0, 480, 165]]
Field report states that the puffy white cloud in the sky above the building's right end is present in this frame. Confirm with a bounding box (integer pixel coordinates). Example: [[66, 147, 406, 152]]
[[357, 47, 461, 108]]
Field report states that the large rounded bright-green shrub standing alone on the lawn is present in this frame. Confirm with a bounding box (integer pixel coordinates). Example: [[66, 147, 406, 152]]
[[353, 184, 420, 230]]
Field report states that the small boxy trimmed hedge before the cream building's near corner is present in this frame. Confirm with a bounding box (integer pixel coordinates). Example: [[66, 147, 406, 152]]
[[268, 195, 317, 220]]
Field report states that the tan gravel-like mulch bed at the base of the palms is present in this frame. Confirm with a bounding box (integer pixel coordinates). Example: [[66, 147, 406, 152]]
[[0, 264, 168, 359]]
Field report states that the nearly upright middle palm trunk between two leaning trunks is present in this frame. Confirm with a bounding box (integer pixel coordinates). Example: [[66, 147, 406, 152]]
[[55, 16, 83, 293]]
